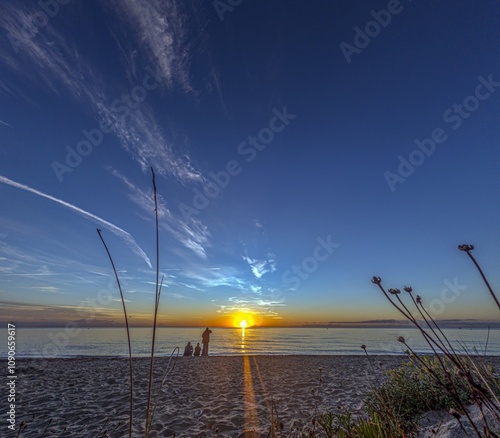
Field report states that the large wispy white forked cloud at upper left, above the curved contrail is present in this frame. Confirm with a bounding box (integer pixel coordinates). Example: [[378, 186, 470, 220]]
[[0, 0, 204, 183]]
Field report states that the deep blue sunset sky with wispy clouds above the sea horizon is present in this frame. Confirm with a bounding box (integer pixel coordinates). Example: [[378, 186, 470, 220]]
[[0, 0, 500, 326]]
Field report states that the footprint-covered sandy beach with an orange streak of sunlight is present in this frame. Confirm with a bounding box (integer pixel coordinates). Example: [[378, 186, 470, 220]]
[[2, 356, 500, 437]]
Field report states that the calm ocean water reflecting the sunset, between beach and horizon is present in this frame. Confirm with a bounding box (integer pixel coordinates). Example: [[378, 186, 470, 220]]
[[6, 328, 500, 357]]
